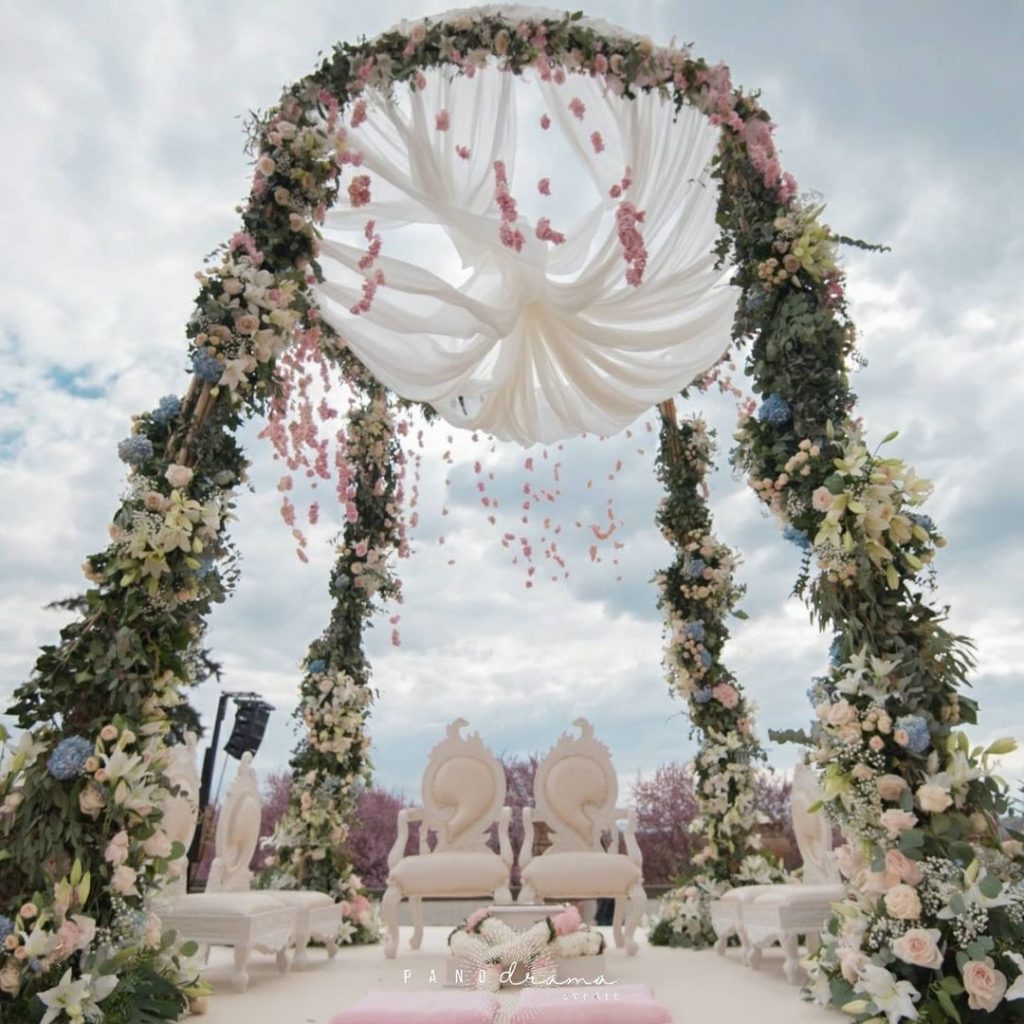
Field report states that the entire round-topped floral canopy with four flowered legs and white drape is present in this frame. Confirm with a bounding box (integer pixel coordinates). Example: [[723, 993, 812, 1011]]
[[0, 7, 1024, 1024]]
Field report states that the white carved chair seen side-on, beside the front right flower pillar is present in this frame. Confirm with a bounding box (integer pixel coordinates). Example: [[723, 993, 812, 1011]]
[[711, 765, 846, 984]]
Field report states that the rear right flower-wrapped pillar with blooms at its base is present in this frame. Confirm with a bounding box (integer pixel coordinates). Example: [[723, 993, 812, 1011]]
[[648, 402, 785, 949]]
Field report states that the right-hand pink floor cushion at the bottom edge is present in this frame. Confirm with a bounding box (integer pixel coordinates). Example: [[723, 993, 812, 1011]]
[[512, 985, 672, 1024]]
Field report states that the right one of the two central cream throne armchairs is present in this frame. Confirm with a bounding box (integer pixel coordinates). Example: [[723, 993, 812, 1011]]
[[519, 718, 647, 956]]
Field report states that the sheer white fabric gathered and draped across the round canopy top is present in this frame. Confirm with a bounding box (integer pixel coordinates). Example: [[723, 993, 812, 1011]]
[[318, 67, 737, 445]]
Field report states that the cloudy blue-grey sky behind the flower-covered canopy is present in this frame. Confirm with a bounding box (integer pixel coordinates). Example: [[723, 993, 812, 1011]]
[[0, 0, 1024, 794]]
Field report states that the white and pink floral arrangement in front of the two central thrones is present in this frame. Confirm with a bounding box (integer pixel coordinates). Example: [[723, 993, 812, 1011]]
[[449, 906, 604, 991]]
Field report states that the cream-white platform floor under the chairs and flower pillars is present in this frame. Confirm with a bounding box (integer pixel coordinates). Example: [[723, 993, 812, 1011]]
[[197, 927, 831, 1024]]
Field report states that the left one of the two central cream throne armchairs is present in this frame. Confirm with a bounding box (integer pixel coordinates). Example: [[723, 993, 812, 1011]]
[[382, 718, 512, 957]]
